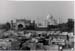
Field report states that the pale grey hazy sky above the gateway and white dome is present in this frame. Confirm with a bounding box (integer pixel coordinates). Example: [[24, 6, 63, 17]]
[[0, 0, 74, 23]]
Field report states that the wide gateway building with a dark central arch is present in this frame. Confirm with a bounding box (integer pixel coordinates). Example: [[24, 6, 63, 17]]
[[11, 19, 31, 30]]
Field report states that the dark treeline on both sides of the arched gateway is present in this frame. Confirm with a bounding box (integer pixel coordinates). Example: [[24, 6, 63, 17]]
[[0, 19, 74, 32]]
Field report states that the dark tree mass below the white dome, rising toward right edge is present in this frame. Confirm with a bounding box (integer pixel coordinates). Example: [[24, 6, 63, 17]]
[[48, 19, 74, 32]]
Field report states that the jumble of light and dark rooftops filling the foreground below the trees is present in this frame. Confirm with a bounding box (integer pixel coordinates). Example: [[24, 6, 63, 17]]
[[0, 30, 73, 50]]
